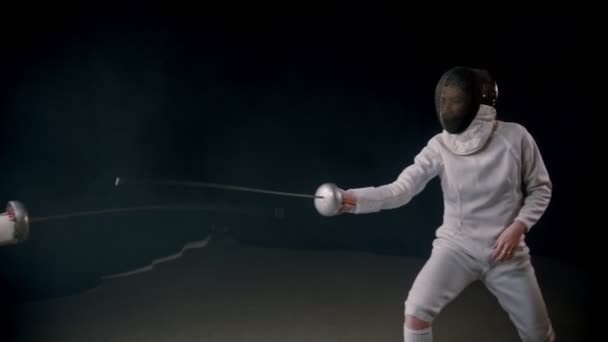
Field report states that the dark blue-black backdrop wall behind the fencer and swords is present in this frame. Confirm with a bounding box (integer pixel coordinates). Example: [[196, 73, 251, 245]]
[[0, 6, 587, 304]]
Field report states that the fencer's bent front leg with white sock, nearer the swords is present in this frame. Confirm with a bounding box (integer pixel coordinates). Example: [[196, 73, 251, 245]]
[[403, 241, 482, 342]]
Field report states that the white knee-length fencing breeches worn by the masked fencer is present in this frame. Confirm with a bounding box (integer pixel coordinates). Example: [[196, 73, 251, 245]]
[[405, 241, 555, 342]]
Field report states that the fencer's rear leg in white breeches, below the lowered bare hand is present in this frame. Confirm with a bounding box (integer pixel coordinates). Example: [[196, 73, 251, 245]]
[[482, 254, 555, 342]]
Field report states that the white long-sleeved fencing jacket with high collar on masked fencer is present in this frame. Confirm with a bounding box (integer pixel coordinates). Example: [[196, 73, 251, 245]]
[[347, 105, 552, 257]]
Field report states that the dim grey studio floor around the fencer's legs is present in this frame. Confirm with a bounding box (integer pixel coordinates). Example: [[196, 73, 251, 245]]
[[10, 240, 587, 342]]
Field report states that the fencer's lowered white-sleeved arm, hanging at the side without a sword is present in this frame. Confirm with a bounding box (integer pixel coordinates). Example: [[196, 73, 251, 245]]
[[515, 127, 553, 232]]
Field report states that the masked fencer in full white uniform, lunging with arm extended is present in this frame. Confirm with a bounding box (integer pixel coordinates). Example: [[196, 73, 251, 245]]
[[340, 67, 555, 342]]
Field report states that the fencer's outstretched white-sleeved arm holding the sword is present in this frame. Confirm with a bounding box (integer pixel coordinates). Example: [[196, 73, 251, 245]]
[[346, 138, 443, 214]]
